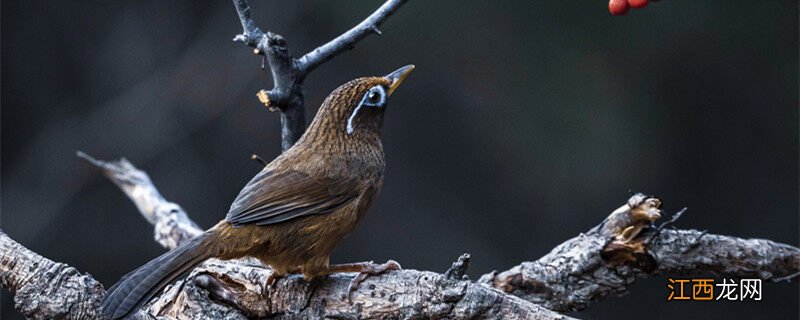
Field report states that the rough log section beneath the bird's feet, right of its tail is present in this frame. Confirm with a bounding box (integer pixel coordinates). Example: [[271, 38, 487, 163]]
[[141, 259, 571, 319]]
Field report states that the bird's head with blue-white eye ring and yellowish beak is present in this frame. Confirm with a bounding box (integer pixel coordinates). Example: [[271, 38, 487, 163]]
[[307, 65, 414, 144]]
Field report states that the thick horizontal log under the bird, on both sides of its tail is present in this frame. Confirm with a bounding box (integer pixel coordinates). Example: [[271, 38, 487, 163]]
[[0, 231, 570, 320]]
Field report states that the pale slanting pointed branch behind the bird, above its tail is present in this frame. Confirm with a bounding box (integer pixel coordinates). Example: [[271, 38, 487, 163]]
[[77, 151, 203, 249]]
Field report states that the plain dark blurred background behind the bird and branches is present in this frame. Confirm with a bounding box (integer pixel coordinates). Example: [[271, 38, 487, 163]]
[[1, 0, 800, 319]]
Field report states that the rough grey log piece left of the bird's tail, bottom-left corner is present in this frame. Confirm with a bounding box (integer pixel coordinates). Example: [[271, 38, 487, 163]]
[[0, 230, 105, 319]]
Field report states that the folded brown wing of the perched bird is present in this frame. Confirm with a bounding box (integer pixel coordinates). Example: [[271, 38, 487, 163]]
[[225, 170, 358, 227]]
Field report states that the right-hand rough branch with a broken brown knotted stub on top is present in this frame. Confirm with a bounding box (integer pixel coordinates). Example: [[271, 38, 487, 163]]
[[479, 194, 800, 312]]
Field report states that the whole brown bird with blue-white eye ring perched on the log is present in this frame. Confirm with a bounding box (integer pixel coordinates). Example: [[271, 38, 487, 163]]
[[103, 65, 414, 319]]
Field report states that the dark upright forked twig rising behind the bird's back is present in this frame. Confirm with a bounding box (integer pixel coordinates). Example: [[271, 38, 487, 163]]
[[233, 0, 408, 151]]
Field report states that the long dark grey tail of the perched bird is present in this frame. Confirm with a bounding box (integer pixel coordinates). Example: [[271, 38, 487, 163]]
[[103, 232, 212, 319]]
